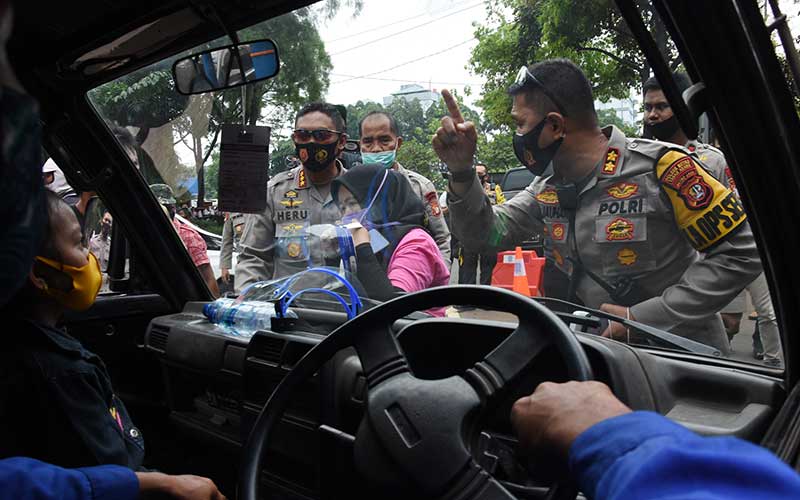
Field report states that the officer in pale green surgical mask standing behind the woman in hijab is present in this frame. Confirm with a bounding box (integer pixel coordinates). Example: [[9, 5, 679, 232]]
[[359, 111, 451, 268]]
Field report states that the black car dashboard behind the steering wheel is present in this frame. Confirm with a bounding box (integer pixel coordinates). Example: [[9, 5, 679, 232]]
[[145, 302, 784, 498]]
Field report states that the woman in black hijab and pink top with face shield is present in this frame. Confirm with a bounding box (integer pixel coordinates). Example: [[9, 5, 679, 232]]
[[331, 164, 450, 315]]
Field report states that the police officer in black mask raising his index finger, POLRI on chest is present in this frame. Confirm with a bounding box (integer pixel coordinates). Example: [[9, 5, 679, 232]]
[[433, 59, 761, 353]]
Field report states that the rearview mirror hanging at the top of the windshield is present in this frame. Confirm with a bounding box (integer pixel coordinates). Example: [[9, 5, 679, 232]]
[[172, 40, 280, 95]]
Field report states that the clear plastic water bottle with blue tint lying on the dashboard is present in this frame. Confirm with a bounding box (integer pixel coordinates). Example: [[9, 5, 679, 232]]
[[203, 298, 296, 337]]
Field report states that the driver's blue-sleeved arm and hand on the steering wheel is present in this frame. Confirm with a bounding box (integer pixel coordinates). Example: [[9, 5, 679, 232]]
[[511, 382, 800, 500]]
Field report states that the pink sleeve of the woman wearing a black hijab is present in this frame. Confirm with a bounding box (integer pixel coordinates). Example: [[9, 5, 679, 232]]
[[387, 229, 450, 292]]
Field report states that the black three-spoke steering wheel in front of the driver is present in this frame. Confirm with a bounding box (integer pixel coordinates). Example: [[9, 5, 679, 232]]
[[239, 286, 592, 500]]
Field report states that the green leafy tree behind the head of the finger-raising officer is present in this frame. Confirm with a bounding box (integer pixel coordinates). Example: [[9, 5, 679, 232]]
[[470, 0, 680, 131]]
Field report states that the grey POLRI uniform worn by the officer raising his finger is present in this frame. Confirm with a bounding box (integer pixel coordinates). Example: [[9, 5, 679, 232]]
[[448, 127, 761, 353]]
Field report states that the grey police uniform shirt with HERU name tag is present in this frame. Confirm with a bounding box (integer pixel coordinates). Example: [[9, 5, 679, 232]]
[[235, 164, 344, 290]]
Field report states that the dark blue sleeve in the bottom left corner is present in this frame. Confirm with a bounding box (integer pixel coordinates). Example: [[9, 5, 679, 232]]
[[0, 457, 139, 500]]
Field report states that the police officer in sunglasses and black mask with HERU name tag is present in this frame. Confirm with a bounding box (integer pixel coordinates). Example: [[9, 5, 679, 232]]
[[234, 102, 347, 290]]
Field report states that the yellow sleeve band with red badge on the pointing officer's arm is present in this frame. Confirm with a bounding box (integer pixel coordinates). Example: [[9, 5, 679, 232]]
[[655, 149, 747, 250]]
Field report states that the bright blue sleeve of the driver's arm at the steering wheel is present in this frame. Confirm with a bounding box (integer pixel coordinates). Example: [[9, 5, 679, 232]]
[[569, 412, 800, 500]]
